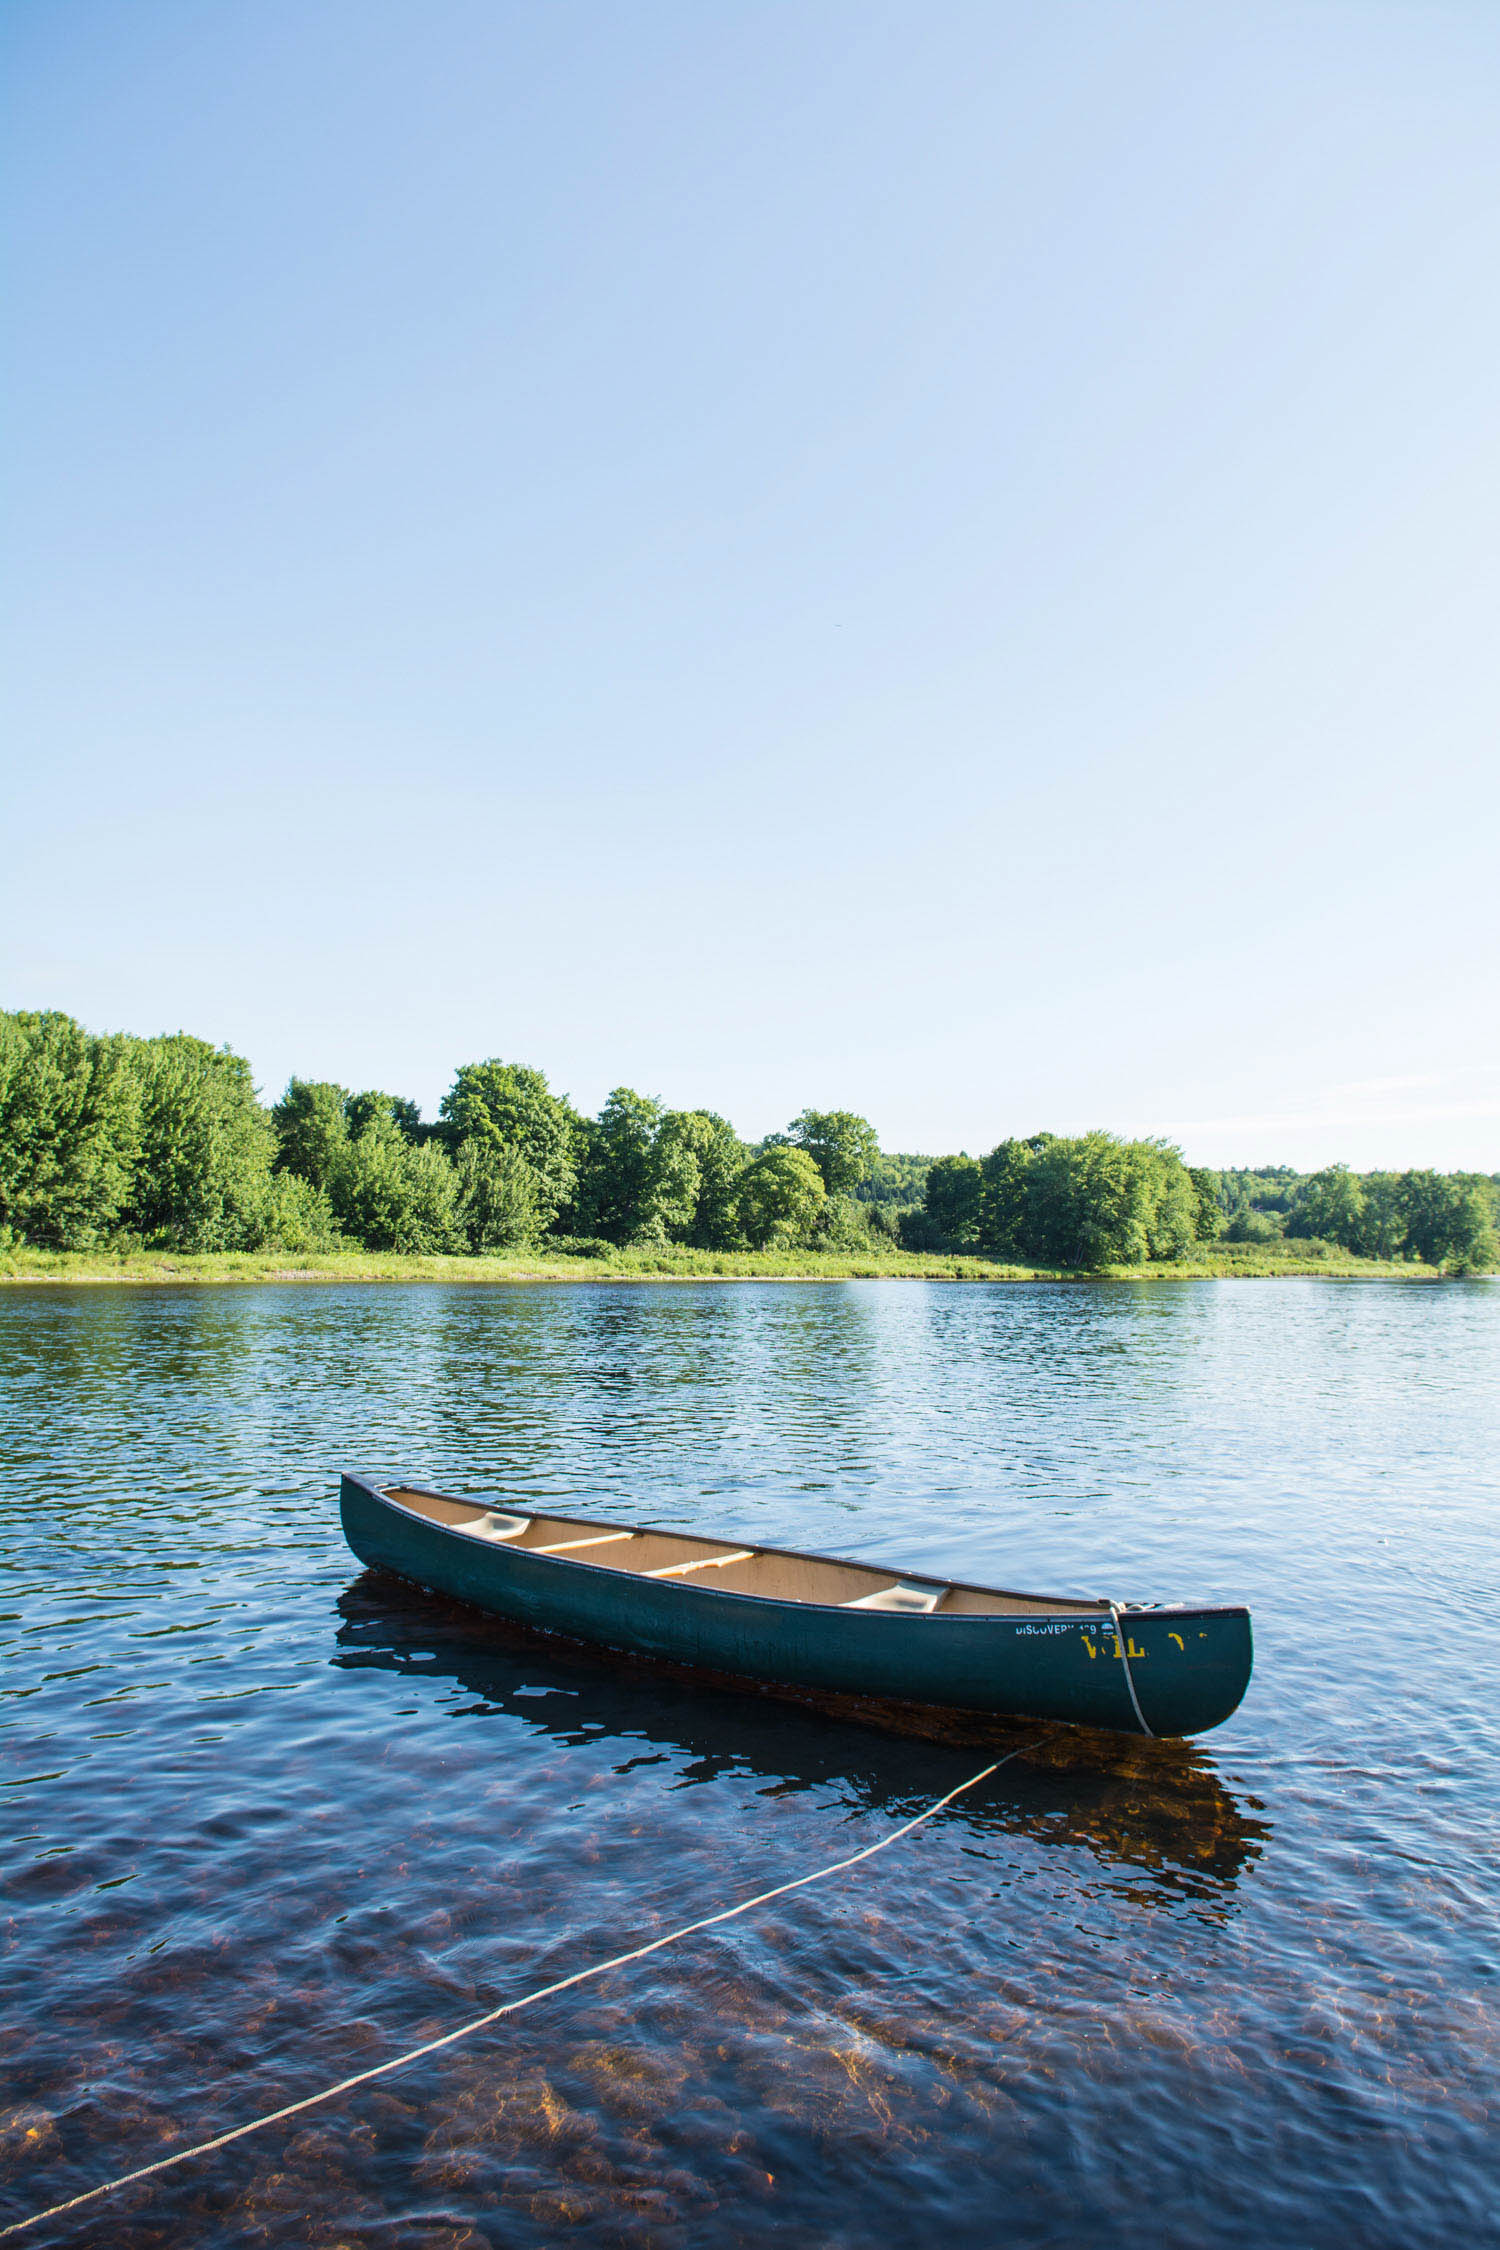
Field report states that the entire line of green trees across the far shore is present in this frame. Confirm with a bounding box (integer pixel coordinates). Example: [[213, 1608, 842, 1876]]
[[0, 1013, 1496, 1271]]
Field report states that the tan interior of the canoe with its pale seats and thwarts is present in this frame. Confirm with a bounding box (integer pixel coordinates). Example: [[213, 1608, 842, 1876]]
[[387, 1485, 1109, 1618]]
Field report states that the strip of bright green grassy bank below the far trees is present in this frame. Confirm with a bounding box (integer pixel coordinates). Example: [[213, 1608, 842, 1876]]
[[0, 1242, 1439, 1285]]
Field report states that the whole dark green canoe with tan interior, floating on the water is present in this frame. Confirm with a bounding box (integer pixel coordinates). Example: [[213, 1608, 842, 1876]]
[[340, 1472, 1253, 1735]]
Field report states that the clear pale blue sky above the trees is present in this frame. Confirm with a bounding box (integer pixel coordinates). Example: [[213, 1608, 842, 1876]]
[[0, 0, 1500, 1170]]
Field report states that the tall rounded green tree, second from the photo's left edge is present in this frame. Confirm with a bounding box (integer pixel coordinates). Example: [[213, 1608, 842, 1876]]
[[121, 1031, 277, 1251]]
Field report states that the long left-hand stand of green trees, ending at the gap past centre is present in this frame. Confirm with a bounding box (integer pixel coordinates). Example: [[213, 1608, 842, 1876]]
[[0, 1013, 897, 1253]]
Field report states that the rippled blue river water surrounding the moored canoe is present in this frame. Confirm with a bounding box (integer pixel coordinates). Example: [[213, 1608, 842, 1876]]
[[0, 1283, 1500, 2250]]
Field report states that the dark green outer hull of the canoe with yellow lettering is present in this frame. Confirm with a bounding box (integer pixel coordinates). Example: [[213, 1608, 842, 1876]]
[[340, 1474, 1253, 1735]]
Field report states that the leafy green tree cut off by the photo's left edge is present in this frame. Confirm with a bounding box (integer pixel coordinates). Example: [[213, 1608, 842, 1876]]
[[0, 1010, 139, 1251]]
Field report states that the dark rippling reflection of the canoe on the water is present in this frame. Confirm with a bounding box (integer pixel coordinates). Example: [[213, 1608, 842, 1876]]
[[333, 1571, 1268, 1904]]
